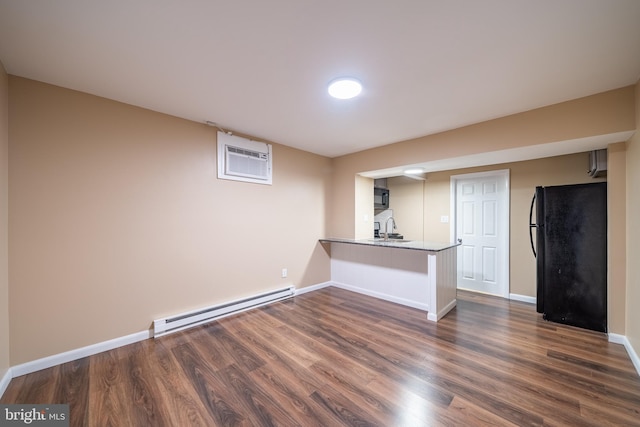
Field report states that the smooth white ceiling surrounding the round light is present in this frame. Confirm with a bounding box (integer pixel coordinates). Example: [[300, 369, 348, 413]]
[[0, 0, 640, 157]]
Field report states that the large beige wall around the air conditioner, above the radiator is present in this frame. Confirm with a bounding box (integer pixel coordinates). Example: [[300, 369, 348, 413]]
[[3, 76, 331, 365]]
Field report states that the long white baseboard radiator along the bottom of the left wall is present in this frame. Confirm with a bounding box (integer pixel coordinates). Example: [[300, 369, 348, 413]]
[[153, 286, 295, 338]]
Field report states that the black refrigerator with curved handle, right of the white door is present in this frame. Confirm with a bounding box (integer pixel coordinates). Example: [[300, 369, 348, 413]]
[[529, 182, 607, 332]]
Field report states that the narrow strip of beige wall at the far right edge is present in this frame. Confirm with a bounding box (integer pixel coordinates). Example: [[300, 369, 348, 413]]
[[625, 82, 640, 355]]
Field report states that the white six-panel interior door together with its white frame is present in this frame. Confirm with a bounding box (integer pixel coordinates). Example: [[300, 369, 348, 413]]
[[451, 170, 509, 298]]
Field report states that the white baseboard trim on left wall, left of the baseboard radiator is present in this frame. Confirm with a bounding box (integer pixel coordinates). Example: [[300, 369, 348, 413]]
[[11, 331, 151, 378]]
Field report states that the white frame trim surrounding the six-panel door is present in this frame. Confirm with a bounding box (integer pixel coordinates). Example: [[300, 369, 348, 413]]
[[449, 169, 511, 299]]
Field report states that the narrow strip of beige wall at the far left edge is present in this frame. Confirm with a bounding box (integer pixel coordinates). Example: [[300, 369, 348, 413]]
[[0, 62, 10, 380]]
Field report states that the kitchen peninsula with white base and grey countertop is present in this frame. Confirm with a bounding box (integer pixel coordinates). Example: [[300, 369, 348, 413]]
[[320, 238, 459, 322]]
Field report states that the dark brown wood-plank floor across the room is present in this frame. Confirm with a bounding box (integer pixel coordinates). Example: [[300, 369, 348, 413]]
[[0, 288, 640, 426]]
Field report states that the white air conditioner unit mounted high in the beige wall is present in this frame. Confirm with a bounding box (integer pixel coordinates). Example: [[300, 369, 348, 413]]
[[218, 132, 272, 185]]
